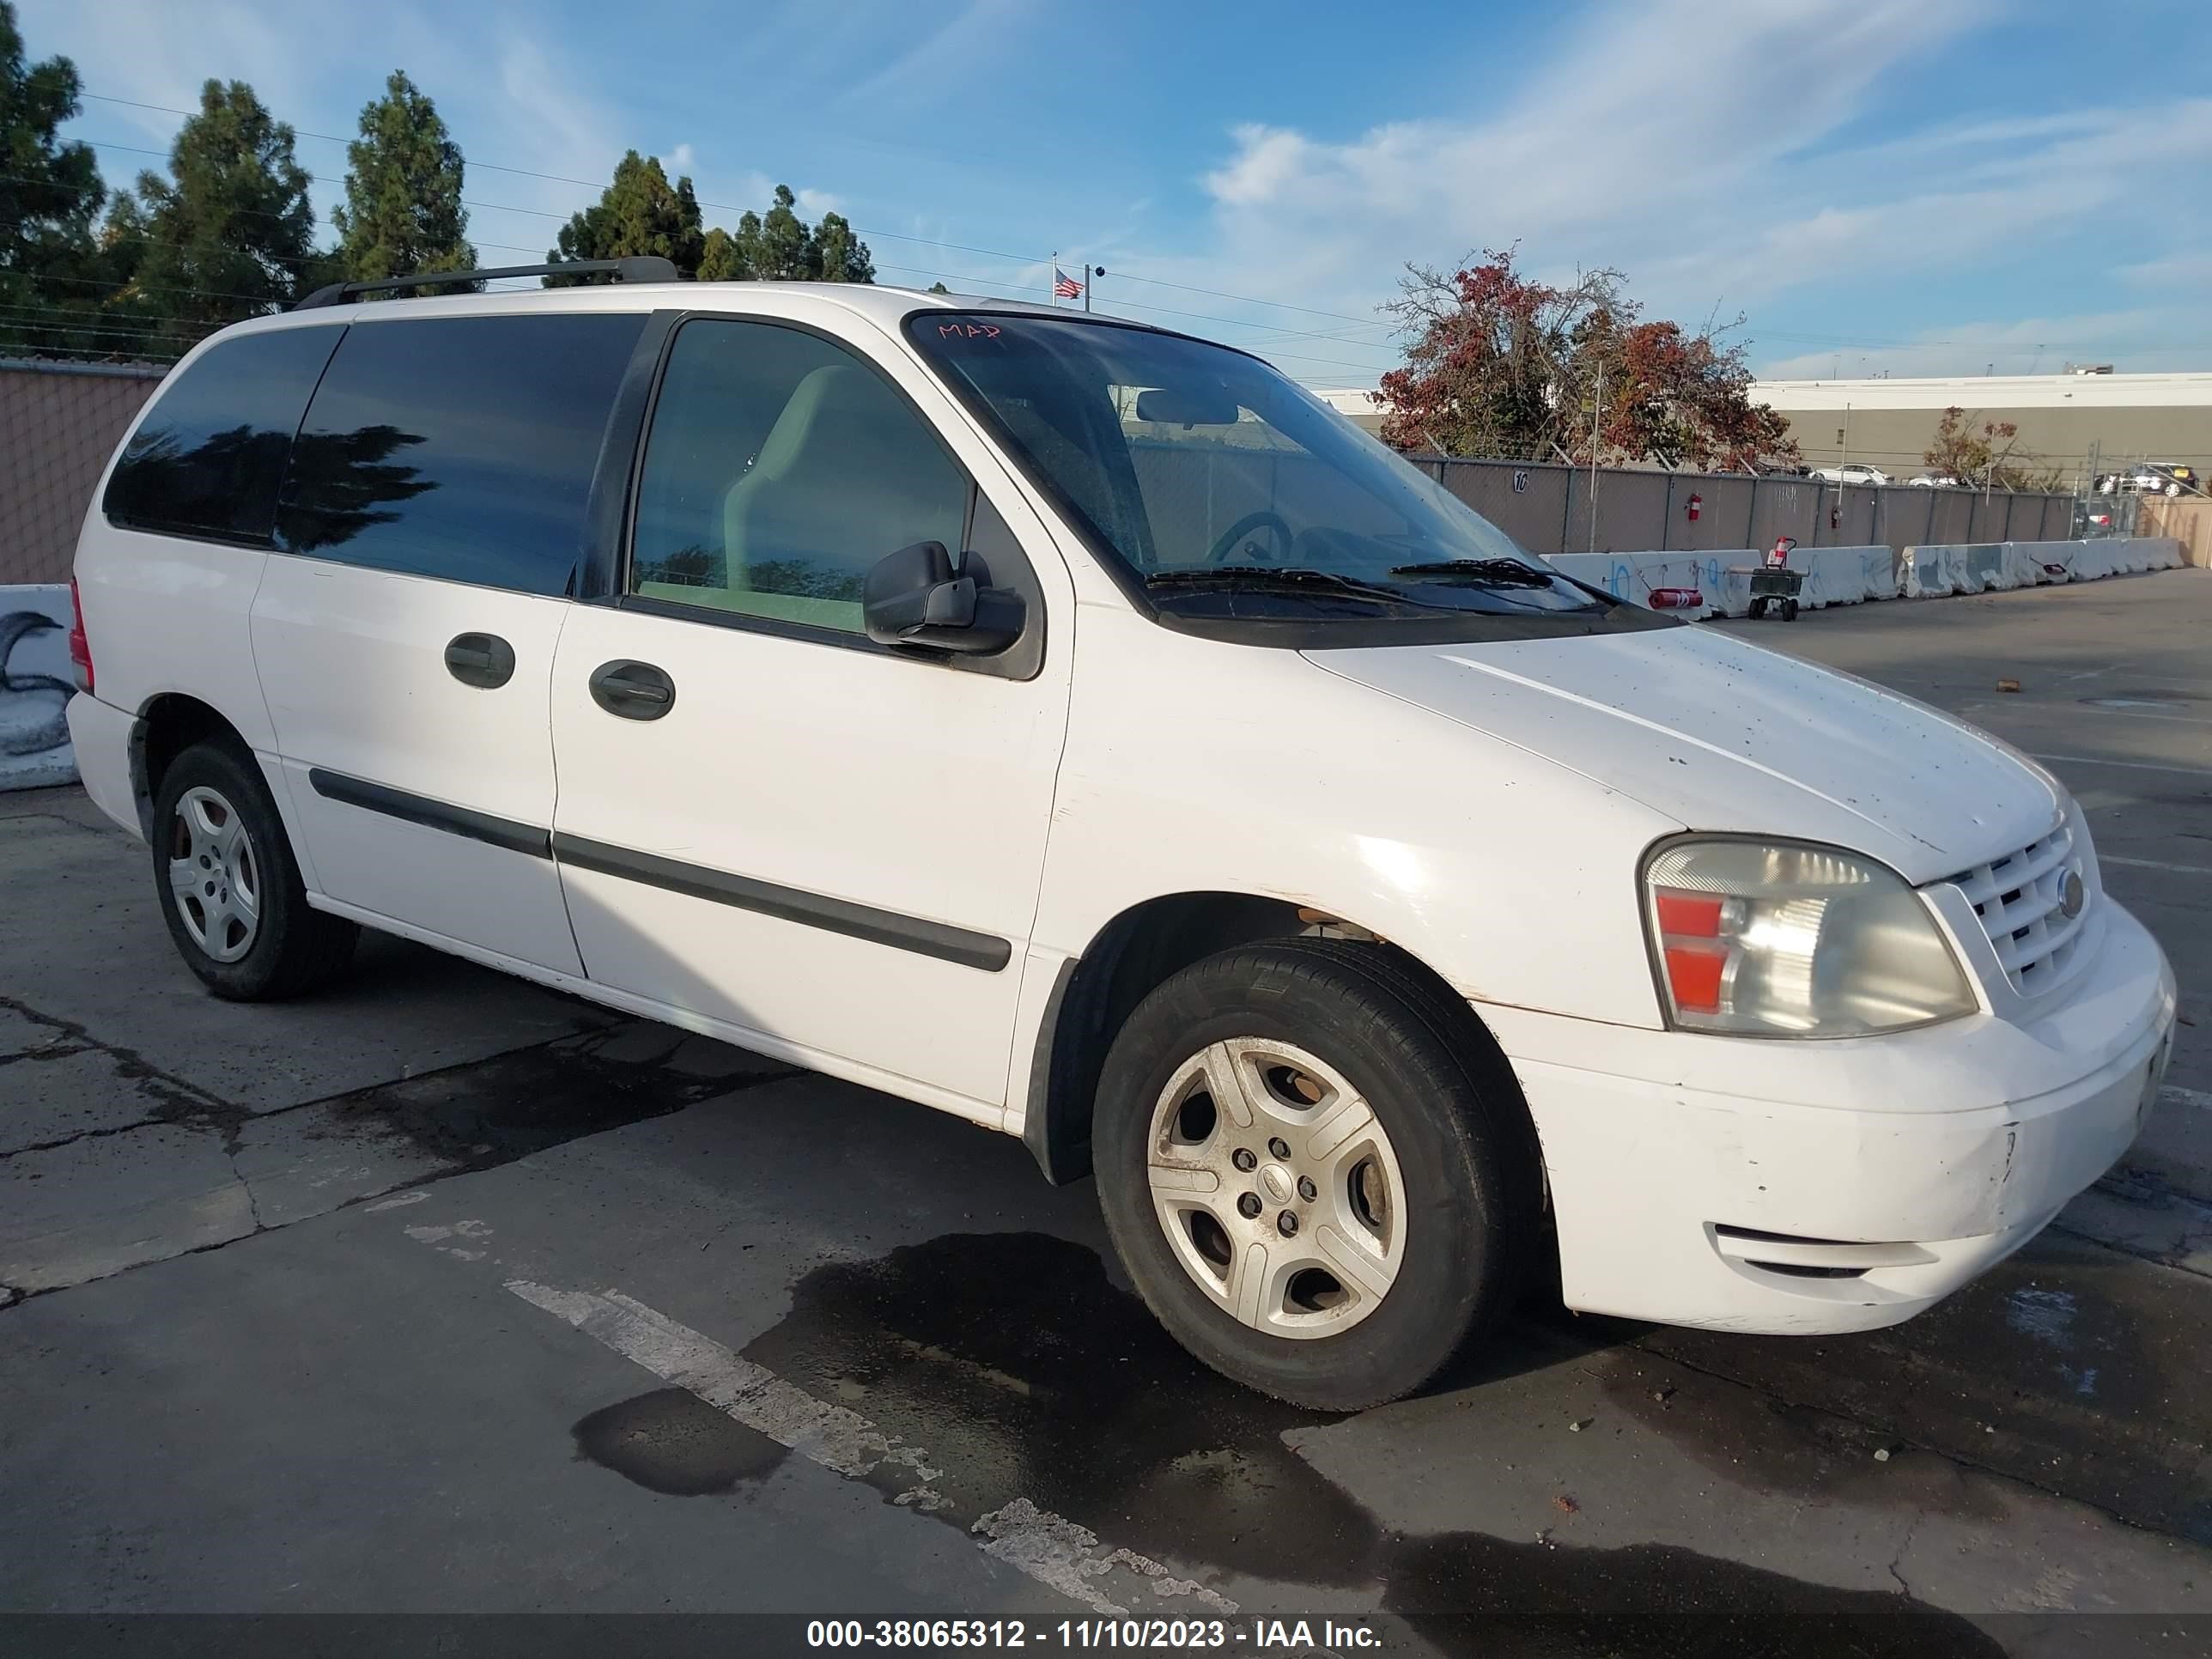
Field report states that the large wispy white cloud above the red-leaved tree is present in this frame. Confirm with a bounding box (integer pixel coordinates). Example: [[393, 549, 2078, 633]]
[[1201, 0, 2212, 369]]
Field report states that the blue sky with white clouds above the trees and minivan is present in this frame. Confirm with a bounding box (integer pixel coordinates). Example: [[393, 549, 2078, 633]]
[[30, 0, 2212, 385]]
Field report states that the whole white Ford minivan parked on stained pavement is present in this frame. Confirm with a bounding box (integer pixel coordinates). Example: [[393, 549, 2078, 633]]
[[69, 268, 2174, 1409]]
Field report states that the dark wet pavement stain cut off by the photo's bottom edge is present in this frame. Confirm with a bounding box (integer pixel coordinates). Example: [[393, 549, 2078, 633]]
[[1382, 1533, 2004, 1659]]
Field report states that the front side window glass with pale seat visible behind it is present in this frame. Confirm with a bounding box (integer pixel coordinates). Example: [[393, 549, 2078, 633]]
[[629, 319, 969, 633]]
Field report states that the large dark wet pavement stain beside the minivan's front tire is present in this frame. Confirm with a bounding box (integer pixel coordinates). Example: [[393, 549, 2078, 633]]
[[745, 1234, 1378, 1586]]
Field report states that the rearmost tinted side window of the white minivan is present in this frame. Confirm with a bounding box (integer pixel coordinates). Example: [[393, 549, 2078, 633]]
[[100, 327, 345, 546]]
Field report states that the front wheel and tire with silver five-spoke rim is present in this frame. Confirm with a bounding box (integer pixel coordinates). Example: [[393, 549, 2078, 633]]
[[1093, 938, 1541, 1411]]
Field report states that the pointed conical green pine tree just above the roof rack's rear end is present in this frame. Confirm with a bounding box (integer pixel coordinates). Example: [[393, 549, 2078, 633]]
[[331, 70, 476, 292]]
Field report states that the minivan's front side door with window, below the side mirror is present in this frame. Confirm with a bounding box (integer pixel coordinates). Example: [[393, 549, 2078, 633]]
[[553, 312, 1073, 1115]]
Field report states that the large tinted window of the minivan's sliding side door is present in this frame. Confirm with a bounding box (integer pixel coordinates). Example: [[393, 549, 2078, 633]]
[[276, 312, 646, 592]]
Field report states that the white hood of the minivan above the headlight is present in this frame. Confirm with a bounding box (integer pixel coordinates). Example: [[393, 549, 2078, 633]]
[[1307, 629, 2063, 884]]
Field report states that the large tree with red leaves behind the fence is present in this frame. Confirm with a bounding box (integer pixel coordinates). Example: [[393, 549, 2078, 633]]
[[1376, 248, 1798, 471]]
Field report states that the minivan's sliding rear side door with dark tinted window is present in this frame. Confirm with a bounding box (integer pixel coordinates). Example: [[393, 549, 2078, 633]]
[[252, 305, 644, 973]]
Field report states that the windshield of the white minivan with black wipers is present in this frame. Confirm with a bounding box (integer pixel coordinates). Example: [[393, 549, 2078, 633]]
[[907, 312, 1613, 623]]
